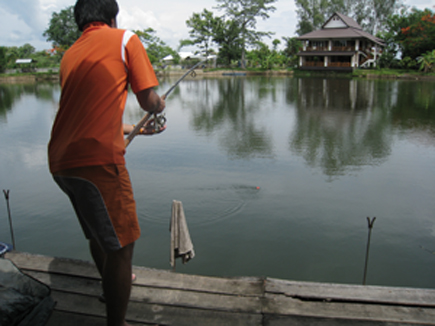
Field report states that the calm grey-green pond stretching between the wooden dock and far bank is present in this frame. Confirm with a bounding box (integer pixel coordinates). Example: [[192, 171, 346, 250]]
[[0, 76, 435, 288]]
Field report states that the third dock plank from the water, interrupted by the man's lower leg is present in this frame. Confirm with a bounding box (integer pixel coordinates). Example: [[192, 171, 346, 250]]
[[53, 291, 262, 326]]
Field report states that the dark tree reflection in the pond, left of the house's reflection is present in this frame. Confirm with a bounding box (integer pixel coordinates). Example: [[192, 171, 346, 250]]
[[175, 78, 274, 159]]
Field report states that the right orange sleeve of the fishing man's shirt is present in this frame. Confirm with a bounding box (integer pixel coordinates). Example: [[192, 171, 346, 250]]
[[125, 34, 159, 94]]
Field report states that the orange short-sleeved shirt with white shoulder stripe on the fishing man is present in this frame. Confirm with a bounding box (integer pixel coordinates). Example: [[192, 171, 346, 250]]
[[48, 23, 158, 173]]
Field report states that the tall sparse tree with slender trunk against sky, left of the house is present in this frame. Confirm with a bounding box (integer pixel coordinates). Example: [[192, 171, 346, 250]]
[[217, 0, 276, 68]]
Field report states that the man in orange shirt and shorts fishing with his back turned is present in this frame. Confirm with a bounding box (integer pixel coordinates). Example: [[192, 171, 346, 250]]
[[48, 0, 165, 326]]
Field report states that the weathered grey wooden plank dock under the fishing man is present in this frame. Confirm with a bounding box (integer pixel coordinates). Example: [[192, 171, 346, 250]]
[[5, 252, 435, 326]]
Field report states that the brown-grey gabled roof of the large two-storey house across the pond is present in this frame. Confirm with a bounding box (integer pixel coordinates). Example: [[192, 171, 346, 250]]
[[298, 13, 385, 46]]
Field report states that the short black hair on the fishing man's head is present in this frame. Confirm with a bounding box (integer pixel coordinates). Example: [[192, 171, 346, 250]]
[[74, 0, 119, 31]]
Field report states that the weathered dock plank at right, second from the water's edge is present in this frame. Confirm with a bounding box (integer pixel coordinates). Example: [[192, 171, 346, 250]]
[[263, 294, 435, 325]]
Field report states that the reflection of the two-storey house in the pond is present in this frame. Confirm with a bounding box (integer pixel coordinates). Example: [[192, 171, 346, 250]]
[[289, 78, 395, 177]]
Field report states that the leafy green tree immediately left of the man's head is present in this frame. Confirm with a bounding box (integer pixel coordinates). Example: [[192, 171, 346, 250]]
[[42, 6, 81, 49]]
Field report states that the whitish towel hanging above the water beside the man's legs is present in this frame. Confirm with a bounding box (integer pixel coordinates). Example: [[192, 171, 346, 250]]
[[169, 200, 195, 267]]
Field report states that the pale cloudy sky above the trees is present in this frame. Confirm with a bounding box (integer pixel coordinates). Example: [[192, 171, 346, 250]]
[[0, 0, 435, 51]]
